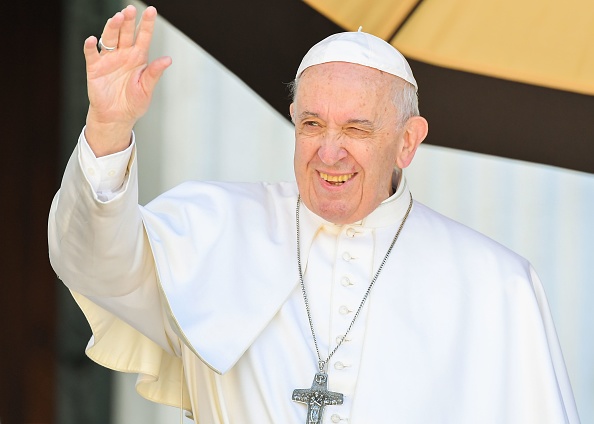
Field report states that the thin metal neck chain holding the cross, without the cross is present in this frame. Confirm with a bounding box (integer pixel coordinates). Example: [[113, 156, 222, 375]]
[[295, 195, 413, 372]]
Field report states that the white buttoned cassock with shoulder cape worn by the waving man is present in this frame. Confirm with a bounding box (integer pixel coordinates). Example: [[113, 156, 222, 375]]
[[49, 131, 579, 424]]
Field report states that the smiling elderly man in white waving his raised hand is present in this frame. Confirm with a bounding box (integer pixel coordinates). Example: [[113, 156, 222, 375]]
[[49, 6, 579, 424]]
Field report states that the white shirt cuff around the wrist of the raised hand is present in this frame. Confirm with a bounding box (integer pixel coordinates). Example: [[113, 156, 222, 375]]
[[78, 128, 135, 202]]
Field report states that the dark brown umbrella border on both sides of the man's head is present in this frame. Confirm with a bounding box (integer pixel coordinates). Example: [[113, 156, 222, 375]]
[[152, 0, 594, 173]]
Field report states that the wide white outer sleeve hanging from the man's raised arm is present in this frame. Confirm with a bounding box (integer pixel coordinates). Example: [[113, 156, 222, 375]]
[[48, 133, 179, 358]]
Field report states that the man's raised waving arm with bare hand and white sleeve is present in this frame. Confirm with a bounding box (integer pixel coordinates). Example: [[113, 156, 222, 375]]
[[48, 6, 177, 350]]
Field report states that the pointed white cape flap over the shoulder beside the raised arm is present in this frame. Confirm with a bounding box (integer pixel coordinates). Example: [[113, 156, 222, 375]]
[[142, 183, 306, 373]]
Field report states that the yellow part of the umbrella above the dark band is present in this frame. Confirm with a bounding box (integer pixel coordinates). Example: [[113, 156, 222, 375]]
[[305, 0, 594, 95]]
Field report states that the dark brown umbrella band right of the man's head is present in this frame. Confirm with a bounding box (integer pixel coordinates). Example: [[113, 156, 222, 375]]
[[409, 60, 594, 173]]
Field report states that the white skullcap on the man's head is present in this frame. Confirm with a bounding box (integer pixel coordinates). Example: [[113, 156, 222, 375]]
[[295, 29, 418, 89]]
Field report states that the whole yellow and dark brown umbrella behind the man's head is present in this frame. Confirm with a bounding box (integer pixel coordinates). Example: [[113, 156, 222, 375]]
[[152, 0, 594, 172]]
